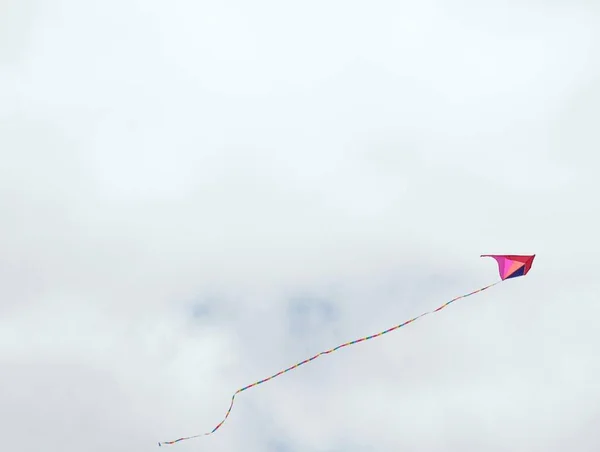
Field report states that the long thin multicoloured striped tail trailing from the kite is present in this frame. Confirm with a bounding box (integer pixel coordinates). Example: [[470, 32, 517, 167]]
[[158, 281, 502, 446]]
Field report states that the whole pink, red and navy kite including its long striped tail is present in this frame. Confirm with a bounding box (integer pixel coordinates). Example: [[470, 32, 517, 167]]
[[158, 254, 535, 446]]
